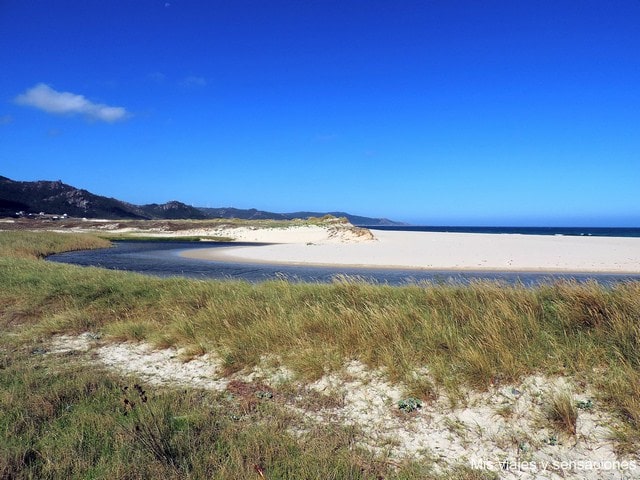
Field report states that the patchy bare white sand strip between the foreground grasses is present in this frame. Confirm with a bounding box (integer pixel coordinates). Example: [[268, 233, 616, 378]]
[[50, 334, 640, 479]]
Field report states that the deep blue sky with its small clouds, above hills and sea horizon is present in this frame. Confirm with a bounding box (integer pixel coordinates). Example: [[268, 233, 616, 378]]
[[0, 0, 640, 226]]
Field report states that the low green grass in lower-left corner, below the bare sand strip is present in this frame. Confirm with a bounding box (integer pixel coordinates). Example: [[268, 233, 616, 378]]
[[0, 349, 436, 479]]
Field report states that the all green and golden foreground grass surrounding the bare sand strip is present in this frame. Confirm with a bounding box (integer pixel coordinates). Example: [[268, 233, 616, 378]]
[[0, 232, 640, 478]]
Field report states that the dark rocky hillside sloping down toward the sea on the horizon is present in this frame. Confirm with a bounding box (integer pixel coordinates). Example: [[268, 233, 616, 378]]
[[0, 176, 401, 226]]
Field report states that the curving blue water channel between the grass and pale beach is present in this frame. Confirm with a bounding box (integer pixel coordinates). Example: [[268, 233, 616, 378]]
[[47, 241, 640, 286]]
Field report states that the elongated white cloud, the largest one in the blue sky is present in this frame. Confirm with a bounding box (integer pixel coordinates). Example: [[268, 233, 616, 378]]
[[15, 83, 129, 122]]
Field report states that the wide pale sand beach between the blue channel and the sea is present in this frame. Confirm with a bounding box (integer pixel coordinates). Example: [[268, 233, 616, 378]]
[[184, 227, 640, 273]]
